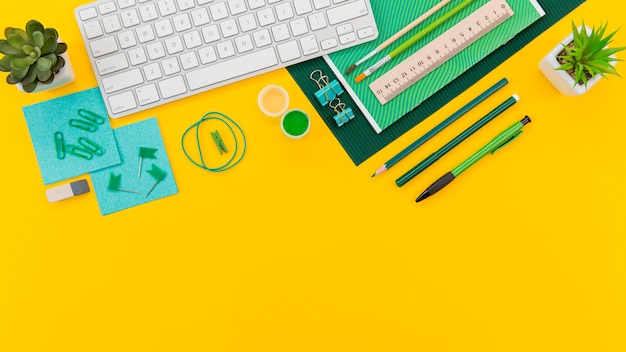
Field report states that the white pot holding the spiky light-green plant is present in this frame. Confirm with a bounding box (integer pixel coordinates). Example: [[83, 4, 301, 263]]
[[539, 26, 615, 96]]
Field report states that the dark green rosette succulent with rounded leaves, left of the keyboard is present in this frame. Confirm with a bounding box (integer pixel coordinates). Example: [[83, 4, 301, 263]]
[[0, 20, 67, 93]]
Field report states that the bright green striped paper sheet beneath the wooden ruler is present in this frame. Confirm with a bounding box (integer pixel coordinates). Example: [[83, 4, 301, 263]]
[[329, 0, 541, 133]]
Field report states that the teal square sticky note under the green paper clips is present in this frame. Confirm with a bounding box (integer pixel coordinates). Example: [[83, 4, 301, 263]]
[[22, 88, 120, 185]]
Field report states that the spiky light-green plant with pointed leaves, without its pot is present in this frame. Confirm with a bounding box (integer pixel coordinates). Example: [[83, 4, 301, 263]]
[[557, 20, 626, 88]]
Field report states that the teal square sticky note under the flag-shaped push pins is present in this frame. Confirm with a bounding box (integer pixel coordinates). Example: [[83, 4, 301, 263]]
[[91, 117, 178, 215]]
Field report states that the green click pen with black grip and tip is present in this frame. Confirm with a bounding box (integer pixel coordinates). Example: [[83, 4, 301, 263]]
[[415, 116, 530, 202]]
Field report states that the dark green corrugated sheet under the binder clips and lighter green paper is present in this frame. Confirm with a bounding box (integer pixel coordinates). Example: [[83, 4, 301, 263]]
[[287, 0, 585, 165]]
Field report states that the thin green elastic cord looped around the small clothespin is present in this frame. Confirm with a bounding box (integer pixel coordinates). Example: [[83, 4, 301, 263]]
[[181, 111, 246, 172]]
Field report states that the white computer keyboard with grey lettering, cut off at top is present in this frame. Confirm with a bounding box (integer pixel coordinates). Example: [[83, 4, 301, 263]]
[[75, 0, 378, 118]]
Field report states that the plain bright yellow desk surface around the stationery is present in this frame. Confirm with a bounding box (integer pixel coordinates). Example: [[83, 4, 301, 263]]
[[0, 0, 626, 352]]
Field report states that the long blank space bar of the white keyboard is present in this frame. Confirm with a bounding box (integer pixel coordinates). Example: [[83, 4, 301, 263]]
[[186, 47, 278, 90]]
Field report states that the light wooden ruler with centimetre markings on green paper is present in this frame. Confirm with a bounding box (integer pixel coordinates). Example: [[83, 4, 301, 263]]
[[369, 0, 513, 105]]
